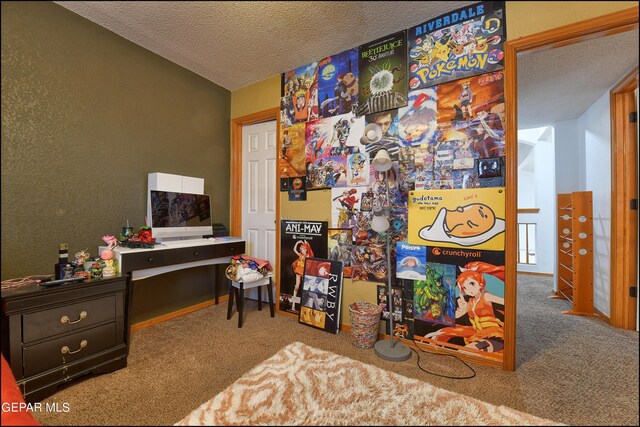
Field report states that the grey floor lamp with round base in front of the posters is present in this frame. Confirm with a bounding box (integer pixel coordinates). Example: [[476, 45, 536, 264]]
[[371, 148, 411, 362]]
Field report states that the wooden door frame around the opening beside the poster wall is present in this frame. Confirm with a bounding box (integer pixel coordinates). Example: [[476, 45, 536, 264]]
[[503, 7, 639, 371]]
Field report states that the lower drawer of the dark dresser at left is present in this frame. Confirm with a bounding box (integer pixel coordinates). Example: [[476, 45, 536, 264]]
[[22, 323, 124, 377]]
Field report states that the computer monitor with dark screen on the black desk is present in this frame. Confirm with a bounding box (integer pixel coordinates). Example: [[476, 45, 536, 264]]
[[147, 190, 213, 241]]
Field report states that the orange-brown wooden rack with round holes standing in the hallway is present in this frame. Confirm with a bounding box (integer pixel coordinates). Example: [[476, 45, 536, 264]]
[[551, 191, 595, 316]]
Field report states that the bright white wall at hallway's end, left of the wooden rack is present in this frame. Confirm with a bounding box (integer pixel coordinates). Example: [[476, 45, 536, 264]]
[[518, 128, 557, 274]]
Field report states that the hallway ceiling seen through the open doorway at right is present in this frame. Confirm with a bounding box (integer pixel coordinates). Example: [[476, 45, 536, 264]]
[[507, 30, 638, 129]]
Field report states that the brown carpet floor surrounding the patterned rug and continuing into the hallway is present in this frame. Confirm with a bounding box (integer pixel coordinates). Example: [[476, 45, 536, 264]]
[[34, 275, 639, 425]]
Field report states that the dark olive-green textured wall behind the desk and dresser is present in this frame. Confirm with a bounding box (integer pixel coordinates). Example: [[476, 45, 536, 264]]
[[2, 2, 230, 280]]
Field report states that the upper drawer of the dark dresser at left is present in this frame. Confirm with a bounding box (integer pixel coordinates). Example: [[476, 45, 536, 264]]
[[22, 293, 118, 344]]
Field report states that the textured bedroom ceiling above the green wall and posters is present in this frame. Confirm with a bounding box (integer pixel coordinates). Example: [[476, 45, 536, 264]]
[[55, 1, 475, 91]]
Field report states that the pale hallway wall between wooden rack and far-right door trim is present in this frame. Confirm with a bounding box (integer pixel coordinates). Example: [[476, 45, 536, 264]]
[[577, 91, 611, 316]]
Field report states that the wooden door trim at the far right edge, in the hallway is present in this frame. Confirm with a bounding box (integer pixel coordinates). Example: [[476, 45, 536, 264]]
[[609, 66, 638, 329]]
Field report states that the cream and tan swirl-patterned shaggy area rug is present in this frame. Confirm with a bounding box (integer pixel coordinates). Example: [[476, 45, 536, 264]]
[[175, 342, 559, 425]]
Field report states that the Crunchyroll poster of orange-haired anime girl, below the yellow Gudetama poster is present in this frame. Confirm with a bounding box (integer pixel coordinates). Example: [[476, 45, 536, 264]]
[[414, 246, 504, 360]]
